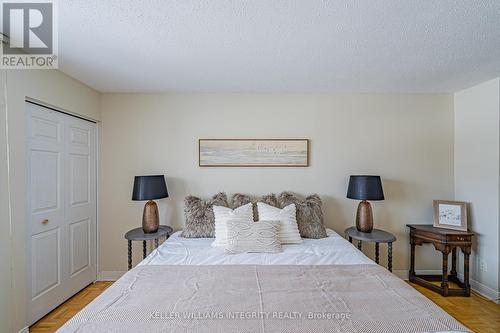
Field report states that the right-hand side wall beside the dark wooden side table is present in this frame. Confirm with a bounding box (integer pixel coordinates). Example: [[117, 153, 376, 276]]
[[454, 78, 500, 292]]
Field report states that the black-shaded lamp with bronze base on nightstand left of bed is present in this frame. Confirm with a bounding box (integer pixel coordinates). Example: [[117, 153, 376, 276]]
[[132, 175, 168, 234]]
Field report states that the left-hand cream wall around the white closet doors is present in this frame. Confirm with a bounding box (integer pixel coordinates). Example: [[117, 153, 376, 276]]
[[0, 70, 100, 332]]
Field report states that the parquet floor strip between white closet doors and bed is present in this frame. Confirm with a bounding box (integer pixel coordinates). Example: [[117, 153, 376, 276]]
[[30, 282, 113, 333]]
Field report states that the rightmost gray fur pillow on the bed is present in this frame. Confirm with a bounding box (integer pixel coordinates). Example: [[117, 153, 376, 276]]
[[278, 192, 327, 239]]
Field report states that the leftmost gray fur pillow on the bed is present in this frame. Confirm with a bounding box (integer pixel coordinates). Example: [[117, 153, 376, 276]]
[[181, 192, 229, 238]]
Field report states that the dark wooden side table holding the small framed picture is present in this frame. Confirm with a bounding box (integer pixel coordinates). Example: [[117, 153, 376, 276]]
[[406, 224, 474, 296]]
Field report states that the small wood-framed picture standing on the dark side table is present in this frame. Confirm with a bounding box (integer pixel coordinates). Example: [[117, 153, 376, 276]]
[[434, 200, 467, 231]]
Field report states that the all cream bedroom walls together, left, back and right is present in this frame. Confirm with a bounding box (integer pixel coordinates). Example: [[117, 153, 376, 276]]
[[0, 70, 500, 332]]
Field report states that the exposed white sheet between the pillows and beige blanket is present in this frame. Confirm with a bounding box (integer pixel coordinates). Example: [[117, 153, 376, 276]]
[[139, 229, 375, 265]]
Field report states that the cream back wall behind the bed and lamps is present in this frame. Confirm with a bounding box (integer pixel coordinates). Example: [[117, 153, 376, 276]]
[[99, 94, 454, 274]]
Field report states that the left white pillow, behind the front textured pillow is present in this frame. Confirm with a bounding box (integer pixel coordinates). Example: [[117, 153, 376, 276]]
[[213, 203, 253, 246]]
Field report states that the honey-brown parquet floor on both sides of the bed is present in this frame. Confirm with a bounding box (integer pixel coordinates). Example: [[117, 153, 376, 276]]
[[30, 282, 500, 333]]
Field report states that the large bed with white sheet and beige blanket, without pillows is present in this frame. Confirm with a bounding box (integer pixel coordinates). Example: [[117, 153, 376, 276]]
[[58, 230, 470, 333]]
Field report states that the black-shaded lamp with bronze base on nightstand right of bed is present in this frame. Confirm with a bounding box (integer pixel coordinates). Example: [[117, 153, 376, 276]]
[[347, 176, 384, 232]]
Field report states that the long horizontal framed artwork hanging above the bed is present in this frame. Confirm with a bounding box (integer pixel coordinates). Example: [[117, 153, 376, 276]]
[[199, 139, 309, 167]]
